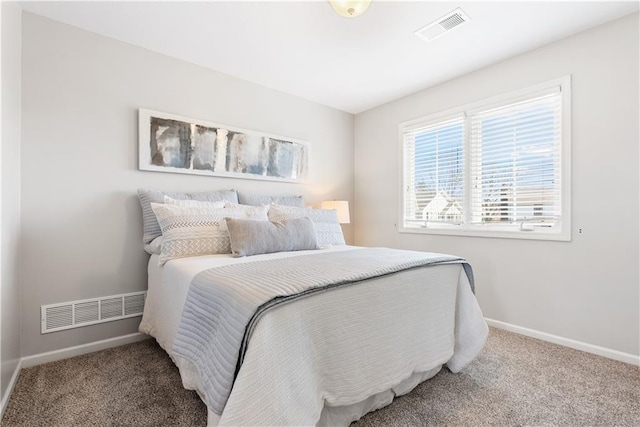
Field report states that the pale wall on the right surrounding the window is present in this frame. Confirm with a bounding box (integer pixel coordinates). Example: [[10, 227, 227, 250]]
[[354, 13, 640, 355]]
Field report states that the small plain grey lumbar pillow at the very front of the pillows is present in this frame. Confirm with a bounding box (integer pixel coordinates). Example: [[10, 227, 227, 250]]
[[225, 217, 318, 257]]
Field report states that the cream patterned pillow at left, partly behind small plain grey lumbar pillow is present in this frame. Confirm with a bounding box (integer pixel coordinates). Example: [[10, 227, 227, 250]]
[[151, 203, 269, 265]]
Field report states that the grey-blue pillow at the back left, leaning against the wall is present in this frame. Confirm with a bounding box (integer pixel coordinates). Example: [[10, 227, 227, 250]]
[[138, 188, 238, 244]]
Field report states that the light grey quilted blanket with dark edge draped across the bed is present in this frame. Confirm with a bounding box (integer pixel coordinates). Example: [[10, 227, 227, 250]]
[[173, 248, 473, 415]]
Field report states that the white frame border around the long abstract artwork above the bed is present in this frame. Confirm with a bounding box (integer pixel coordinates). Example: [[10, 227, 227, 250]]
[[138, 108, 311, 184]]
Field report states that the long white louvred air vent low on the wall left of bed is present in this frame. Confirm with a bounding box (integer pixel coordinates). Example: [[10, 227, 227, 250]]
[[40, 292, 147, 334]]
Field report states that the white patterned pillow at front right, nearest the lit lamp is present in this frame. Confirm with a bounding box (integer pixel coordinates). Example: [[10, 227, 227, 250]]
[[269, 205, 345, 246]]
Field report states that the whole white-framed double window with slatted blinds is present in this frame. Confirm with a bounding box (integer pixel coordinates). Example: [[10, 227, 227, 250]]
[[400, 77, 570, 240]]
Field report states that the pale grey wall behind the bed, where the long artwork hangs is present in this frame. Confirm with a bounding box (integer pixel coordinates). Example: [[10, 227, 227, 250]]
[[22, 13, 353, 356]]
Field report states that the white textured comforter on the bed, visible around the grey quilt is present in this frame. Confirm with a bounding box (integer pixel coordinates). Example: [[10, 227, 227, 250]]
[[140, 247, 488, 425]]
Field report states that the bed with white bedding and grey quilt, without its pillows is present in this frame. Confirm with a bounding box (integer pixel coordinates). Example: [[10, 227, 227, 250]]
[[134, 189, 488, 426]]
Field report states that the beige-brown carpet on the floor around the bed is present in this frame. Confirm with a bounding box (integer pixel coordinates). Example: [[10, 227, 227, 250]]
[[2, 329, 640, 427]]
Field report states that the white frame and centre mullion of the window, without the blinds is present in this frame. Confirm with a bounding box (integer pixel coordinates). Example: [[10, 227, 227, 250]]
[[397, 75, 571, 241]]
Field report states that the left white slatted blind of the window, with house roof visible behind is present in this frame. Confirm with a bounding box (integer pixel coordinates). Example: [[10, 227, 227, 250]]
[[404, 115, 465, 226]]
